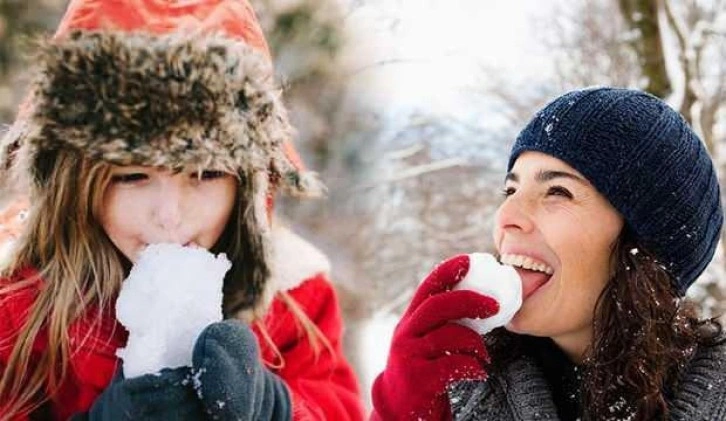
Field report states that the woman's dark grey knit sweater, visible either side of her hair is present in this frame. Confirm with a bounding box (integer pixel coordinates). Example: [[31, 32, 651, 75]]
[[449, 343, 726, 421]]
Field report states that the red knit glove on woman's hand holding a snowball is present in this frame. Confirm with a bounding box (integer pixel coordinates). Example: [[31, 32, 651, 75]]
[[371, 255, 499, 421]]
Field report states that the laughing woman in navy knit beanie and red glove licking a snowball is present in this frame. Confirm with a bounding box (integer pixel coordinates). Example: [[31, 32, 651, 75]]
[[373, 88, 726, 420]]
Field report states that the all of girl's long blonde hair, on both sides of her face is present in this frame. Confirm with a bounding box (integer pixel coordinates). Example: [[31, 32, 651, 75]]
[[0, 150, 336, 419]]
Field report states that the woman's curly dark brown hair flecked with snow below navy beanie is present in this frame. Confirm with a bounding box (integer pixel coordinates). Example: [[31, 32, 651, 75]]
[[487, 227, 726, 421]]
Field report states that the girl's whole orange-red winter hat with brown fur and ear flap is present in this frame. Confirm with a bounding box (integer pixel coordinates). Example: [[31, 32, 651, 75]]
[[0, 0, 322, 313]]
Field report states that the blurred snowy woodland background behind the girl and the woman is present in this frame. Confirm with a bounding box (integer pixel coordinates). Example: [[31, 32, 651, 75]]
[[0, 0, 726, 410]]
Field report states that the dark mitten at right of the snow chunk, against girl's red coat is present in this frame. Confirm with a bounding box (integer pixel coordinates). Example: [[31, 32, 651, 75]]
[[192, 320, 292, 420]]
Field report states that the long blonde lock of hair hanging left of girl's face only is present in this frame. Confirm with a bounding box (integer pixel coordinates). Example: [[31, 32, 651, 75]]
[[0, 150, 123, 416]]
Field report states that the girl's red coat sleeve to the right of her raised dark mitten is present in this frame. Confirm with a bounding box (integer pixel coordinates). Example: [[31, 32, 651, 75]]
[[255, 275, 364, 421]]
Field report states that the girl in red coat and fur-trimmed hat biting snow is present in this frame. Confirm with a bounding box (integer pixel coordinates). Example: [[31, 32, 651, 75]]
[[0, 0, 362, 420]]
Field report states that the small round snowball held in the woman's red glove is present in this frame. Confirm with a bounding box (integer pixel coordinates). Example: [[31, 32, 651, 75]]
[[454, 253, 522, 335]]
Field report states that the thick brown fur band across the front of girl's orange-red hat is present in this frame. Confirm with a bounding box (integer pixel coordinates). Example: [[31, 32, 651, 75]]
[[0, 31, 322, 195]]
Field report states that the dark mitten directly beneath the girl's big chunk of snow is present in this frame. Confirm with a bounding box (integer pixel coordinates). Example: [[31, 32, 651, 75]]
[[74, 367, 205, 421]]
